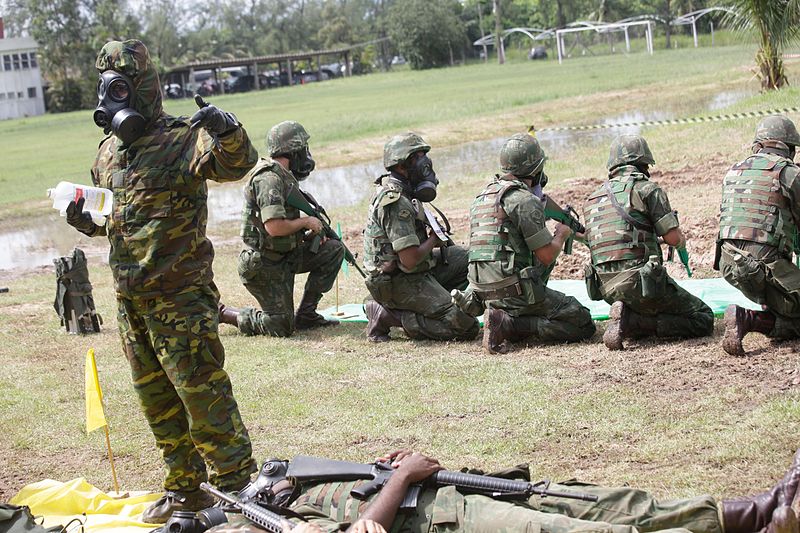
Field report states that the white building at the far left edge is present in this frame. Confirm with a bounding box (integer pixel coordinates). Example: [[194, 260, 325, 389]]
[[0, 37, 44, 120]]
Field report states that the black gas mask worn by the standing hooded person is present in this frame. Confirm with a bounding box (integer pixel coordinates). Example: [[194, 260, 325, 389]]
[[93, 70, 145, 145]]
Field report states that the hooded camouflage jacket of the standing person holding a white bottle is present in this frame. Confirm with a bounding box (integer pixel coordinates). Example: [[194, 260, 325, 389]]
[[91, 41, 258, 297]]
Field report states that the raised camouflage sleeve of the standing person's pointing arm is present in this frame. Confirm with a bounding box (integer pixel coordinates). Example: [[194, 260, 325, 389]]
[[187, 125, 258, 182]]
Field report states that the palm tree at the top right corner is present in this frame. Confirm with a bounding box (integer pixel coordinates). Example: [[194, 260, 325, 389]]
[[729, 0, 800, 91]]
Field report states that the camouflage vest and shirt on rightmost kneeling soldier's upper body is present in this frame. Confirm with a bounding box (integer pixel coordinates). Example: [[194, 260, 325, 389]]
[[719, 150, 800, 262]]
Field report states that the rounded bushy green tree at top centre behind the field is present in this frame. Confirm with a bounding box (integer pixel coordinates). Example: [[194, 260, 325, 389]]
[[387, 0, 466, 69]]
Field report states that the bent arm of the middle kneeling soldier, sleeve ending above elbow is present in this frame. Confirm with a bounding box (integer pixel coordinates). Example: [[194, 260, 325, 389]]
[[501, 190, 571, 266]]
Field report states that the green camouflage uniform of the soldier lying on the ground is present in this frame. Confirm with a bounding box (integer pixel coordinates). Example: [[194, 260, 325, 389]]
[[209, 481, 722, 533]]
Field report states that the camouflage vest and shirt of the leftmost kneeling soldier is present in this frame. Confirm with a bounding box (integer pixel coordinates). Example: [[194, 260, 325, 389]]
[[241, 159, 304, 254]]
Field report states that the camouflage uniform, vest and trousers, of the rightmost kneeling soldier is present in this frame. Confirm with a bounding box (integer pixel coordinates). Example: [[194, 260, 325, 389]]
[[719, 148, 800, 339]]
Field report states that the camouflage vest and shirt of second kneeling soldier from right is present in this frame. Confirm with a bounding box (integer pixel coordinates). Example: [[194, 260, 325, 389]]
[[584, 165, 678, 272]]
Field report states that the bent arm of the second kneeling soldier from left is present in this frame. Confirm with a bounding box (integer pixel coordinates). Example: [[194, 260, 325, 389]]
[[378, 198, 441, 270]]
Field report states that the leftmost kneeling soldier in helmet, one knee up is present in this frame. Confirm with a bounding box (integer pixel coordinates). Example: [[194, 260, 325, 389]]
[[220, 121, 344, 337]]
